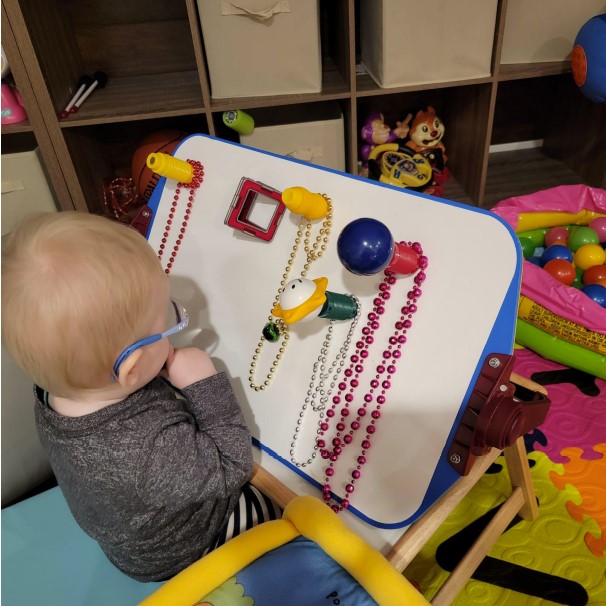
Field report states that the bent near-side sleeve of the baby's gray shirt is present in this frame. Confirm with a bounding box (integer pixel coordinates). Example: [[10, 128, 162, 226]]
[[137, 372, 252, 507]]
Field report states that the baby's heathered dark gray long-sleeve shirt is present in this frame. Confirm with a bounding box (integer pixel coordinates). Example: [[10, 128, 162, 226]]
[[35, 373, 252, 581]]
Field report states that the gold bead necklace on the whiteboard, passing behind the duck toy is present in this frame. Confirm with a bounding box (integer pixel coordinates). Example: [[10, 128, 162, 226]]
[[248, 194, 332, 391]]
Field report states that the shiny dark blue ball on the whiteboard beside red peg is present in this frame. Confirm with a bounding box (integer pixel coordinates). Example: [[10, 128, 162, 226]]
[[337, 218, 395, 276]]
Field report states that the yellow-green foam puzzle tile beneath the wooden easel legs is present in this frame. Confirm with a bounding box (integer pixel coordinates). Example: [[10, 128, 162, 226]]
[[405, 452, 606, 606]]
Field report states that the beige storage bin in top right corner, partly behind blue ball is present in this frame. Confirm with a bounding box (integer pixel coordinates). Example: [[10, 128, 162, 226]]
[[501, 0, 606, 63]]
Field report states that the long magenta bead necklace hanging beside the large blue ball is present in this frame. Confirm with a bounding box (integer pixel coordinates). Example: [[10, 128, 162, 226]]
[[316, 242, 428, 513]]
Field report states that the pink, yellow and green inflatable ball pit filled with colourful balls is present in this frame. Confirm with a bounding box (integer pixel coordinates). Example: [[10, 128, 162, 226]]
[[493, 185, 606, 379]]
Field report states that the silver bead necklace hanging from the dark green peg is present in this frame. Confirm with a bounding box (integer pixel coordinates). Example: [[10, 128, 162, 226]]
[[290, 295, 361, 467]]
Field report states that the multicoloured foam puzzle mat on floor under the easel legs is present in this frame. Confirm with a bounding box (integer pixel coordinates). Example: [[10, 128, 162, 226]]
[[405, 349, 606, 606]]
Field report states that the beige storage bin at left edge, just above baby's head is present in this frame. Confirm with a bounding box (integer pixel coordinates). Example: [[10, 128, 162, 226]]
[[2, 148, 57, 236]]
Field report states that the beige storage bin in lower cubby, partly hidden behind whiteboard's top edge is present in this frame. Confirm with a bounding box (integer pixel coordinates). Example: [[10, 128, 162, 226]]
[[240, 106, 345, 172]]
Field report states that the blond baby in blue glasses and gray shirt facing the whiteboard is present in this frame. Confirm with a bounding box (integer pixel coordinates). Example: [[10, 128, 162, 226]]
[[2, 212, 279, 581]]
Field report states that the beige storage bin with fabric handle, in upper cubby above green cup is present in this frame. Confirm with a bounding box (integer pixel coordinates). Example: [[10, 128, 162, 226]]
[[198, 0, 322, 99]]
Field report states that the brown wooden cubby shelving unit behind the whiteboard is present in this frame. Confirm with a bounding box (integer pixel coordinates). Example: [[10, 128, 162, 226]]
[[2, 0, 606, 213]]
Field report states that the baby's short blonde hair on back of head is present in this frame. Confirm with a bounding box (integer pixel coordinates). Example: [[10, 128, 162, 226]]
[[2, 211, 166, 396]]
